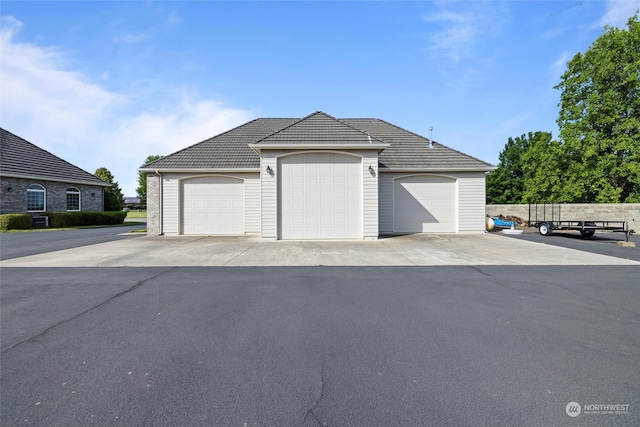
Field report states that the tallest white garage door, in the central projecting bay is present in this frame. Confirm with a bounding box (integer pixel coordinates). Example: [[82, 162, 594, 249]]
[[278, 153, 362, 239]]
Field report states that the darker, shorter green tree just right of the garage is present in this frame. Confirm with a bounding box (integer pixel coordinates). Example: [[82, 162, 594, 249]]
[[487, 132, 551, 204]]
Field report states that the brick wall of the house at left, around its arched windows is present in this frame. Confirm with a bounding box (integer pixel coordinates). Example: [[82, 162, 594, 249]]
[[0, 177, 104, 216]]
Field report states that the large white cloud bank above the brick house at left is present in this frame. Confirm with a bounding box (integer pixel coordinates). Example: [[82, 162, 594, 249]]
[[0, 16, 252, 196]]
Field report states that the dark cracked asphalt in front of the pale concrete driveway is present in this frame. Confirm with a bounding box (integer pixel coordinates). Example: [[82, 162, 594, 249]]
[[0, 231, 640, 426]]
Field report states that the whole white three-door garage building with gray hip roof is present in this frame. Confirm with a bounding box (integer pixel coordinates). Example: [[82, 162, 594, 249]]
[[140, 111, 494, 240]]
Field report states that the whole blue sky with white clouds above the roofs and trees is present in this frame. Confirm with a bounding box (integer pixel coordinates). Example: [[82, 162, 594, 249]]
[[0, 0, 640, 196]]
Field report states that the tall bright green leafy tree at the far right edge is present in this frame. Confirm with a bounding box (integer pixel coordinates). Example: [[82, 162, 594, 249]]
[[549, 13, 640, 203]]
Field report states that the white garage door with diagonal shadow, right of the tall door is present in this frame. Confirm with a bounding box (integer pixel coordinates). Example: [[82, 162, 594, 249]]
[[393, 175, 458, 233]]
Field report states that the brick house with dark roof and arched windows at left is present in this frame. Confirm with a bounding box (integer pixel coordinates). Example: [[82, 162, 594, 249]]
[[0, 128, 110, 217]]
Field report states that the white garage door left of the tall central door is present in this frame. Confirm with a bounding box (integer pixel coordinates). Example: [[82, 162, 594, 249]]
[[182, 176, 244, 235]]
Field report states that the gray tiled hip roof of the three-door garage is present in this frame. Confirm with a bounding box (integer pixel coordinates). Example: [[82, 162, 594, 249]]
[[142, 111, 493, 170]]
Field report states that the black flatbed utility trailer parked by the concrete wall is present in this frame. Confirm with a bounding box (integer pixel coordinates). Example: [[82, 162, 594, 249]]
[[527, 203, 635, 242]]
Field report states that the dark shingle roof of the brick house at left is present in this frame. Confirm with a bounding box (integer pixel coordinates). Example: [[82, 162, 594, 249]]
[[0, 128, 110, 187]]
